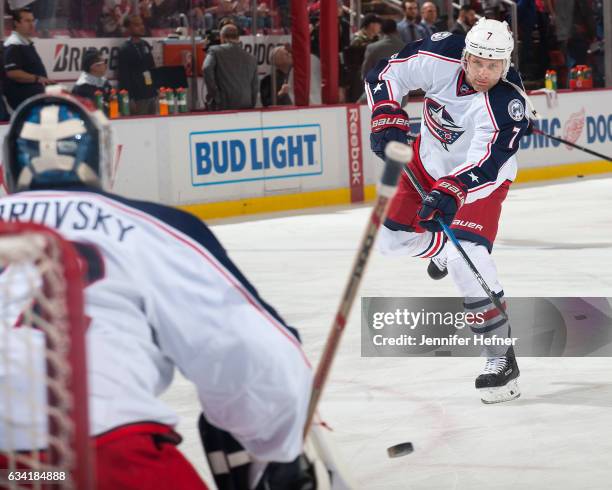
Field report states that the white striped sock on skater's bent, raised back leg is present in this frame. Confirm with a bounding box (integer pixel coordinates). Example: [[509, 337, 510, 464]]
[[376, 226, 444, 258]]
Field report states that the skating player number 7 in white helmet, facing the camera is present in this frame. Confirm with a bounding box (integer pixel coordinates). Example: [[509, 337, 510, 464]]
[[365, 19, 529, 403]]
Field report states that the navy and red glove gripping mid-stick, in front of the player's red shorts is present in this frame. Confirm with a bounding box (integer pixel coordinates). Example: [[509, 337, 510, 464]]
[[418, 177, 467, 231]]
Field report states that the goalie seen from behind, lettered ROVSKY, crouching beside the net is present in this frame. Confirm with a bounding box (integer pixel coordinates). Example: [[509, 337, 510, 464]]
[[0, 93, 346, 490]]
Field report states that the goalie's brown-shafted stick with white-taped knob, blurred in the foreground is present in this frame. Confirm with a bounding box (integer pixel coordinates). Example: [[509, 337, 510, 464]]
[[304, 142, 412, 439]]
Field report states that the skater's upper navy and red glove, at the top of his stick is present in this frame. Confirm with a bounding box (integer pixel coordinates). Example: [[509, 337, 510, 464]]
[[370, 100, 410, 160]]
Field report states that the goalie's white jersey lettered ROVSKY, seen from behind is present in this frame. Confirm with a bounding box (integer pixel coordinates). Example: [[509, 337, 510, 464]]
[[0, 189, 312, 461]]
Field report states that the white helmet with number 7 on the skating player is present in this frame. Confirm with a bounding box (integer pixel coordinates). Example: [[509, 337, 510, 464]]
[[463, 17, 514, 78]]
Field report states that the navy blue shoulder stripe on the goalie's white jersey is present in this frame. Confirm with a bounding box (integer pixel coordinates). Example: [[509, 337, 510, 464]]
[[79, 187, 301, 342]]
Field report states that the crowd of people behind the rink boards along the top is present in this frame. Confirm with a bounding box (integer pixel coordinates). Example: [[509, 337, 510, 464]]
[[0, 0, 604, 118]]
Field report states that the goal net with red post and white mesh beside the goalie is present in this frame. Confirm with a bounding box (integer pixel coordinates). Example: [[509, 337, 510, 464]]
[[0, 223, 93, 489]]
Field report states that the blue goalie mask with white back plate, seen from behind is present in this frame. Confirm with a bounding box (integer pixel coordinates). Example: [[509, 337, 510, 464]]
[[3, 90, 112, 192]]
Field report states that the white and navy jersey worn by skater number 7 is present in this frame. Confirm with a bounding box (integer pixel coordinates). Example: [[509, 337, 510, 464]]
[[365, 32, 528, 202]]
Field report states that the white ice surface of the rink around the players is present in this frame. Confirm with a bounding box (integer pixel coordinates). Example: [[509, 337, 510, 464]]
[[165, 178, 612, 490]]
